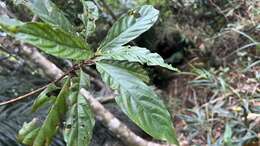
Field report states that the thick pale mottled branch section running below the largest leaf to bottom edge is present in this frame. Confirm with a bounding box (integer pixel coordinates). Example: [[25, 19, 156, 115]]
[[80, 88, 175, 146]]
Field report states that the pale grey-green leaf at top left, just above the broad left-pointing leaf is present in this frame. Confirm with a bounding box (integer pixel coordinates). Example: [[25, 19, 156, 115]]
[[23, 0, 73, 32]]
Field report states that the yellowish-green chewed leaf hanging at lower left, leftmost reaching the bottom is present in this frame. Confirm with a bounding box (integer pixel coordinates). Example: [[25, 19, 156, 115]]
[[18, 78, 70, 146]]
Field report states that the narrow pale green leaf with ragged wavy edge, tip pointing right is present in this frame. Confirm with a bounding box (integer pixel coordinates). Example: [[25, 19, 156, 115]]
[[100, 46, 178, 71]]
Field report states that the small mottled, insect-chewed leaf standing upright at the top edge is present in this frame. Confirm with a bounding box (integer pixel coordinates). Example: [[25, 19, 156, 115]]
[[80, 0, 99, 38]]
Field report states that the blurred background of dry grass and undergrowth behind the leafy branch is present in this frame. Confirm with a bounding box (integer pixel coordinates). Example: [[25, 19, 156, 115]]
[[0, 0, 260, 146]]
